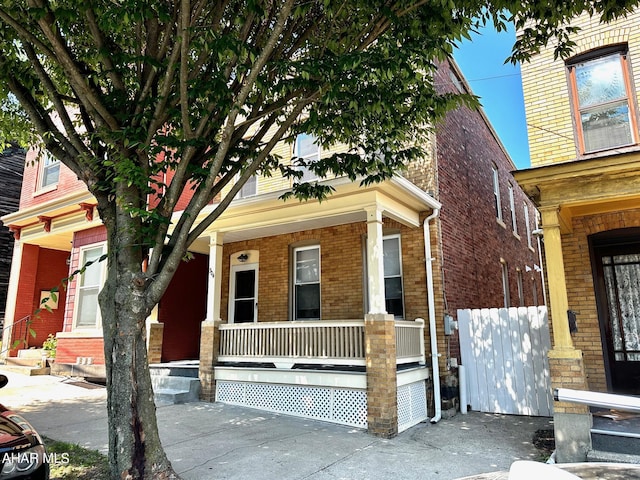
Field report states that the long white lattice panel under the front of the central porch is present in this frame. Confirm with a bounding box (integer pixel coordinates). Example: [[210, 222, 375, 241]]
[[216, 380, 367, 428]]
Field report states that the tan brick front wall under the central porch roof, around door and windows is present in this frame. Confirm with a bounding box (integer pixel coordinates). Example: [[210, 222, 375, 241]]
[[221, 219, 427, 321]]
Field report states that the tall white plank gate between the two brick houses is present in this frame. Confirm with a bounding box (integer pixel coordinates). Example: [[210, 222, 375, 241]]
[[458, 307, 553, 416]]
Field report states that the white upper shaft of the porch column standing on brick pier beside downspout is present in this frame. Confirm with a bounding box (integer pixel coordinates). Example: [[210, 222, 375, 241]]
[[366, 207, 387, 314]]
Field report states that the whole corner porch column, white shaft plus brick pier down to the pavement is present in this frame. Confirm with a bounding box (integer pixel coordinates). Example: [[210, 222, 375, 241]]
[[364, 205, 398, 438]]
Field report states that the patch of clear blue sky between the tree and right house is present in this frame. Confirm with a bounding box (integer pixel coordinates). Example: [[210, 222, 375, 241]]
[[453, 25, 530, 169]]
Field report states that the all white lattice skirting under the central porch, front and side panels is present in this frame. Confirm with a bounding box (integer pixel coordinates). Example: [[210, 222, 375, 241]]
[[216, 380, 428, 432]]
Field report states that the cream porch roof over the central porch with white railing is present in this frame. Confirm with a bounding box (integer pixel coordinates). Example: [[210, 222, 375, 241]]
[[191, 176, 441, 253]]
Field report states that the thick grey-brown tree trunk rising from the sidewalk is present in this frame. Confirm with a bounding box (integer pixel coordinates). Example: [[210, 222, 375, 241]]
[[99, 197, 179, 480]]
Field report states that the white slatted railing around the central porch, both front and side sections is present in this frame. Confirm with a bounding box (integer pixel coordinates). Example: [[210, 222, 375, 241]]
[[218, 319, 425, 368]]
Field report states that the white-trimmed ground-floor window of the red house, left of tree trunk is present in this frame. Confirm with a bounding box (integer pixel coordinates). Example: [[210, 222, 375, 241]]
[[74, 244, 106, 329]]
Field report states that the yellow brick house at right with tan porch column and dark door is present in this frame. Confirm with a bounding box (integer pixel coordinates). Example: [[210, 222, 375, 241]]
[[515, 12, 640, 461]]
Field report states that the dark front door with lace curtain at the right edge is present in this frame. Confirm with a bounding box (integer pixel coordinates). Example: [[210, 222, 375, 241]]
[[594, 232, 640, 394]]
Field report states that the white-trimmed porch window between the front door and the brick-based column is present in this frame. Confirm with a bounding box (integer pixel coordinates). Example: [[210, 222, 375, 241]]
[[293, 245, 320, 320]]
